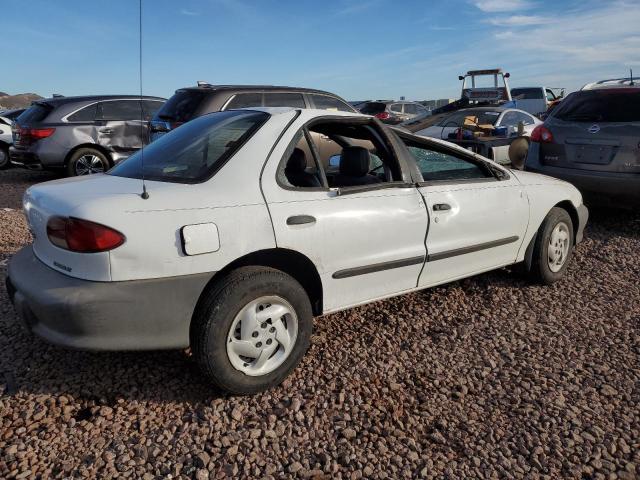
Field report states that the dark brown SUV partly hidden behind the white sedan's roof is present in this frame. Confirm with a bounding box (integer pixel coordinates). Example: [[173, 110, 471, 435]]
[[151, 82, 357, 140]]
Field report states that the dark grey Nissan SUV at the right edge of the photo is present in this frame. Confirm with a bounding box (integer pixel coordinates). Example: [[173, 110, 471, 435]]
[[525, 79, 640, 207]]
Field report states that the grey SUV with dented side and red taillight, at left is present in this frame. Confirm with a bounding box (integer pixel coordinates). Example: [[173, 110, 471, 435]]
[[9, 95, 165, 176]]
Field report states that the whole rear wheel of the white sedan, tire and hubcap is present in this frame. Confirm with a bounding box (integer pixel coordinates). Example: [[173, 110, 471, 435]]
[[190, 267, 313, 395]]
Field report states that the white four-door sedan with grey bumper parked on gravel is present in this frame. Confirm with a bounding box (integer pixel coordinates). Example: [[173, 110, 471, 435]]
[[7, 108, 588, 394]]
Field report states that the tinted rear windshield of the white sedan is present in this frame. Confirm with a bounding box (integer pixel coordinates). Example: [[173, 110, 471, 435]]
[[109, 110, 269, 183]]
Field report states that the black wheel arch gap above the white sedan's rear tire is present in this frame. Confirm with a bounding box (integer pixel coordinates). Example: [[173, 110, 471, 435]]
[[195, 248, 323, 316]]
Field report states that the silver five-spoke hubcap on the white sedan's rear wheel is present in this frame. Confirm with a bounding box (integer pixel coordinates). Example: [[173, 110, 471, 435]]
[[227, 296, 298, 377]]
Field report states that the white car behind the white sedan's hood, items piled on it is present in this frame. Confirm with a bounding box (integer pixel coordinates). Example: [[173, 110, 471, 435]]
[[414, 107, 542, 164]]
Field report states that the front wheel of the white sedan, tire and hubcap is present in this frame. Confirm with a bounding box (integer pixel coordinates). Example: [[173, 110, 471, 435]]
[[528, 207, 573, 285]]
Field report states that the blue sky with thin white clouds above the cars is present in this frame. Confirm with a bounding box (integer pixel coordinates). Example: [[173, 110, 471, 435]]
[[0, 0, 640, 100]]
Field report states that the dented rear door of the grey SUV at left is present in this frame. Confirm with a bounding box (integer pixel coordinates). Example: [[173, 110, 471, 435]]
[[96, 99, 148, 156]]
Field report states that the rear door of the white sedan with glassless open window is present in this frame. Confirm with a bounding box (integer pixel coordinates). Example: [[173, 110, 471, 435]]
[[262, 117, 428, 313]]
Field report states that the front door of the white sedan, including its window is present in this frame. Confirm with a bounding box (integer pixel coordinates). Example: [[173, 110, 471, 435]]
[[403, 133, 529, 287]]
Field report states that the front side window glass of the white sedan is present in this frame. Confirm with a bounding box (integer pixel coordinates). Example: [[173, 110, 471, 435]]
[[405, 142, 494, 182]]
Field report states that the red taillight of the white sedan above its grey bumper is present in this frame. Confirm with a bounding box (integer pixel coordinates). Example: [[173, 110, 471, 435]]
[[47, 217, 126, 253]]
